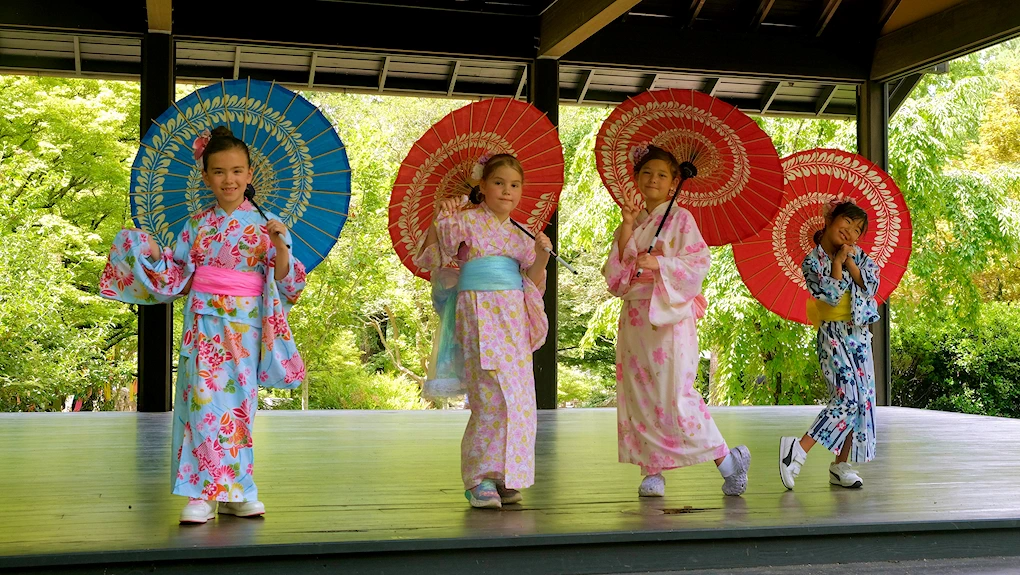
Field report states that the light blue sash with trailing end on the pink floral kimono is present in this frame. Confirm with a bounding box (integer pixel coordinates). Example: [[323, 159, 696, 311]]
[[421, 256, 524, 398]]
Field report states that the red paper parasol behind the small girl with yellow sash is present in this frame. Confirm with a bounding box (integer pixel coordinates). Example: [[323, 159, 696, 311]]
[[733, 149, 912, 323]]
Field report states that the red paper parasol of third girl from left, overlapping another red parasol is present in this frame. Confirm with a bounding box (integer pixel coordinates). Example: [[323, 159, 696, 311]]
[[596, 89, 782, 246]]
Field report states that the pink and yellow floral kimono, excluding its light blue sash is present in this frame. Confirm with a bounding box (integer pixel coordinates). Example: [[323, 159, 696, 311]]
[[415, 204, 549, 489]]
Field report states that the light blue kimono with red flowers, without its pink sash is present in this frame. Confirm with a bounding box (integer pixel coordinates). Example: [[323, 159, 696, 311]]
[[100, 202, 305, 502]]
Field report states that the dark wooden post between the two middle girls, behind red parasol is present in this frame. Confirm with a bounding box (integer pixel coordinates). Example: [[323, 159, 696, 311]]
[[524, 58, 560, 409]]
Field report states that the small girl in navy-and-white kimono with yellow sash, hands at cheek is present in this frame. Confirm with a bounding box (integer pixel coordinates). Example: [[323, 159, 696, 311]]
[[779, 201, 880, 489]]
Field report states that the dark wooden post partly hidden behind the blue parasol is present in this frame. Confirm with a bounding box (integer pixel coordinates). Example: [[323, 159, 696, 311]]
[[138, 32, 174, 412]]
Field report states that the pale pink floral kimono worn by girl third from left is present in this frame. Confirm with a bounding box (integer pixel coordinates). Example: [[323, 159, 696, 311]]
[[602, 199, 728, 474]]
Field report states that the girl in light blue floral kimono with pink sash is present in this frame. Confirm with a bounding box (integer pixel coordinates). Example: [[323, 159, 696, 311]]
[[99, 126, 305, 523]]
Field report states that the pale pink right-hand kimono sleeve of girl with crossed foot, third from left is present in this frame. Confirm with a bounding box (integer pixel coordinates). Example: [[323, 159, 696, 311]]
[[648, 210, 712, 325]]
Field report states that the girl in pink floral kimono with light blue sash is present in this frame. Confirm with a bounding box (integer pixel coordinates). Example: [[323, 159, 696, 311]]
[[415, 154, 552, 509]]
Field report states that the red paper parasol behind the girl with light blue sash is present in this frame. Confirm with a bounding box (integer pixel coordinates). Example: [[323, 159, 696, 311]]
[[390, 98, 563, 279]]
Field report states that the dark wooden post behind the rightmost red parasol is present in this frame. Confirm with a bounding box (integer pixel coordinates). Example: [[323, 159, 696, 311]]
[[857, 81, 893, 406]]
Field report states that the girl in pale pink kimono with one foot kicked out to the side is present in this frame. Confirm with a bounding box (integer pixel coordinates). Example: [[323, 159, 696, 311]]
[[602, 146, 751, 498]]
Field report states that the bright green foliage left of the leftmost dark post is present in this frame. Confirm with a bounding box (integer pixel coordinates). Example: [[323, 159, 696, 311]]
[[0, 76, 139, 411]]
